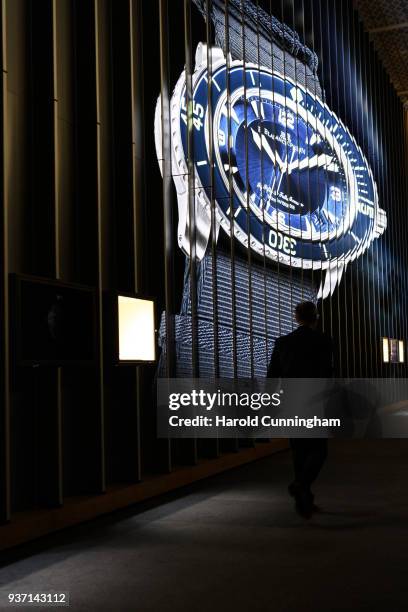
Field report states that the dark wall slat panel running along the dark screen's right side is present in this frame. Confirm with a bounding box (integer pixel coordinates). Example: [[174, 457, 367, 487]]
[[63, 0, 109, 496]]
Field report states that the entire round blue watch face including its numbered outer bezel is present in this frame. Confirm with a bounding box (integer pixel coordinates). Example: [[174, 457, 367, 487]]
[[178, 62, 385, 268]]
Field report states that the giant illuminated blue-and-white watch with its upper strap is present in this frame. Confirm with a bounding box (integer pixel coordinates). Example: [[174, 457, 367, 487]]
[[155, 0, 386, 373]]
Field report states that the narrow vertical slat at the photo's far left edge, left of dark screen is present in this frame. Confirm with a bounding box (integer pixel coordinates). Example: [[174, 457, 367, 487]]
[[0, 0, 11, 523]]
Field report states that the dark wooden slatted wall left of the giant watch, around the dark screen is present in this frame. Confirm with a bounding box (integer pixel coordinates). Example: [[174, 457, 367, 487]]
[[0, 0, 270, 537]]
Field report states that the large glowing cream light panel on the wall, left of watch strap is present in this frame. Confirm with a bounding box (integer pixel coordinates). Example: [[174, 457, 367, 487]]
[[118, 295, 156, 362]]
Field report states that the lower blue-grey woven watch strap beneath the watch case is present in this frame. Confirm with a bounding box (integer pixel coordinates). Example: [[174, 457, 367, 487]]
[[159, 249, 316, 378]]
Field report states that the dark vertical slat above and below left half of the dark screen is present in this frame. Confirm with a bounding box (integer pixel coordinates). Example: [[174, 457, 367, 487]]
[[25, 0, 62, 506]]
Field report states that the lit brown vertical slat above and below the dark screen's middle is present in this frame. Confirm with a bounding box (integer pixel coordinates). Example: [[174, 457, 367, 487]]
[[52, 0, 76, 504]]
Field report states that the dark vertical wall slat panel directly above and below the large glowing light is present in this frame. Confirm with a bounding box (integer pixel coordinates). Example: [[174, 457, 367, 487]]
[[103, 2, 143, 482]]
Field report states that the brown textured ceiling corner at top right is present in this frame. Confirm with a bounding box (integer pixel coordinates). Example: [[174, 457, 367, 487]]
[[354, 0, 408, 107]]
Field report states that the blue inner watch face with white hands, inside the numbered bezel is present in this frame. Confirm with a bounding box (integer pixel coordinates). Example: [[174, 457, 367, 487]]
[[218, 95, 349, 239]]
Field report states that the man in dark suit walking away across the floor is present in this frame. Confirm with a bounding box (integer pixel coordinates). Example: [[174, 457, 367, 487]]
[[267, 302, 333, 518]]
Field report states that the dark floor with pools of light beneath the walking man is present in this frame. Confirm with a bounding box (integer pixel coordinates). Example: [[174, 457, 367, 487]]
[[0, 440, 408, 612]]
